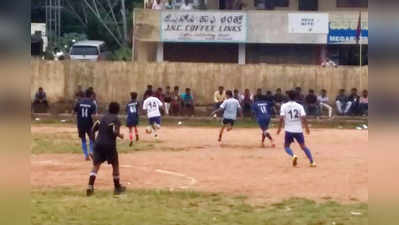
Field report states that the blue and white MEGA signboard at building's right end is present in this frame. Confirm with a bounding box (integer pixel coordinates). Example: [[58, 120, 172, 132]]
[[328, 17, 369, 44]]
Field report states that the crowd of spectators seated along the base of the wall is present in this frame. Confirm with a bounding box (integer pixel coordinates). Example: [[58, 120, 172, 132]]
[[32, 85, 368, 118]]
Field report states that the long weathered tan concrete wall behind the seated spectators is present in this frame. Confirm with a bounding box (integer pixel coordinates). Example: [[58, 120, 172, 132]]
[[31, 60, 368, 105]]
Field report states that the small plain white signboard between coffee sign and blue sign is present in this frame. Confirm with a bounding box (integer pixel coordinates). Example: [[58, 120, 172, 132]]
[[288, 13, 328, 34]]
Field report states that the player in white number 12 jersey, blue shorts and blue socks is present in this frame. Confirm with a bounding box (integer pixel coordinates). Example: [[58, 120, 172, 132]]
[[277, 91, 316, 167]]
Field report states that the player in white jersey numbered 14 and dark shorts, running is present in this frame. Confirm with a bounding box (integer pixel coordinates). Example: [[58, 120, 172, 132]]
[[143, 92, 163, 139]]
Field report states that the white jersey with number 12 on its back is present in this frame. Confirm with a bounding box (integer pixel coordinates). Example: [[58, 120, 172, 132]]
[[280, 101, 306, 133]]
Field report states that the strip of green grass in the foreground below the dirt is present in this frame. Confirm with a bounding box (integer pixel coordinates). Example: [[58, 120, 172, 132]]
[[31, 189, 368, 225]]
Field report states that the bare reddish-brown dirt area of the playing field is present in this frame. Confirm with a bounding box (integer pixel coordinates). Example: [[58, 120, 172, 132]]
[[31, 126, 368, 202]]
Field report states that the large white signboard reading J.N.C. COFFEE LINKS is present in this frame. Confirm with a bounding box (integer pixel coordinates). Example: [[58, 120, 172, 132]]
[[161, 11, 247, 43]]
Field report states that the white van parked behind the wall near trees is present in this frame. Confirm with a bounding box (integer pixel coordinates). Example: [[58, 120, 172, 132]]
[[69, 40, 108, 61]]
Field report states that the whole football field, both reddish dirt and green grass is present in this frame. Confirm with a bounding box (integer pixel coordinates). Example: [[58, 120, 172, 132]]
[[31, 120, 368, 225]]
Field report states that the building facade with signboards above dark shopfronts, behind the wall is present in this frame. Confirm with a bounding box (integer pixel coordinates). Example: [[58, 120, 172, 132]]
[[133, 0, 368, 65]]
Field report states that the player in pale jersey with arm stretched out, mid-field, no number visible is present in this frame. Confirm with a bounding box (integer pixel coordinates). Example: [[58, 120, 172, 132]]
[[210, 90, 243, 143]]
